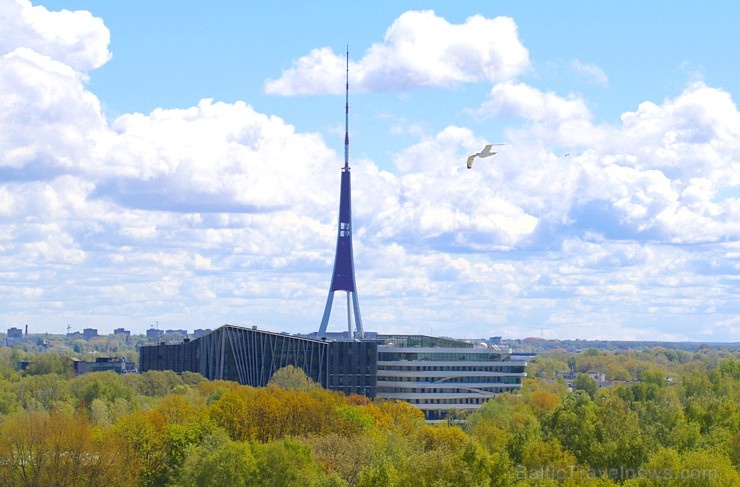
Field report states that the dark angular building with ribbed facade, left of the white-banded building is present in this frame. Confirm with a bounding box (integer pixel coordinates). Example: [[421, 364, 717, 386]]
[[139, 325, 378, 397]]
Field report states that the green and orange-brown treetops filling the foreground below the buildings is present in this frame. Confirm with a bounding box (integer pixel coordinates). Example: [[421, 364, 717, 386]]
[[0, 348, 740, 487]]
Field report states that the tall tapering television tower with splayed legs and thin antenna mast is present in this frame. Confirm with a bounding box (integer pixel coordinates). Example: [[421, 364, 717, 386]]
[[319, 49, 364, 338]]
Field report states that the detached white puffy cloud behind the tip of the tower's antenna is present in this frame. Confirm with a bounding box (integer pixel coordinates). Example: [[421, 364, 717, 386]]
[[265, 10, 530, 95]]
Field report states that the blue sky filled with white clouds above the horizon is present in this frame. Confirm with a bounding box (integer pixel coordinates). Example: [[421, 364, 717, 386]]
[[0, 0, 740, 342]]
